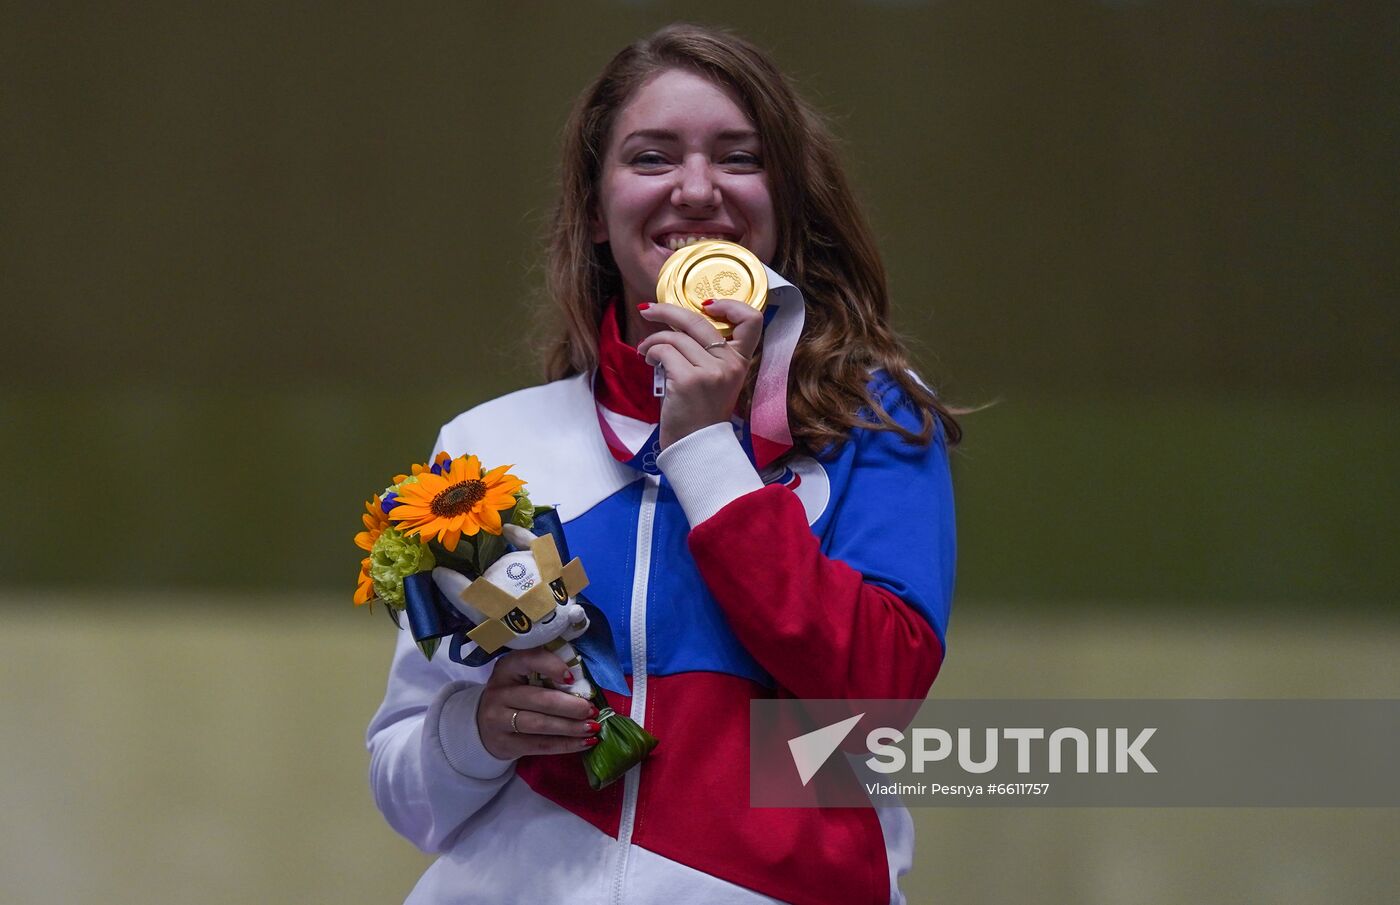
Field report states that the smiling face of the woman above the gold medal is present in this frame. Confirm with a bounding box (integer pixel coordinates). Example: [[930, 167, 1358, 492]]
[[592, 69, 777, 315]]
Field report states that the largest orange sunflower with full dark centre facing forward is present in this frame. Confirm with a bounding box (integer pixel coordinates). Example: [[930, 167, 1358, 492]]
[[389, 455, 525, 551]]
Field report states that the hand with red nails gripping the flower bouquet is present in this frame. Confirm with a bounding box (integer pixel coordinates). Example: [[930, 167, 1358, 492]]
[[476, 647, 601, 761]]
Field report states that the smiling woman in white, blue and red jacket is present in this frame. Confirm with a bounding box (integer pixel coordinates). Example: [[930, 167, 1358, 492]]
[[368, 25, 959, 904]]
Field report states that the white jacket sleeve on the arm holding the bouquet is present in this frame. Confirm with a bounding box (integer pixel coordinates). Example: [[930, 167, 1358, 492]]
[[365, 619, 515, 852]]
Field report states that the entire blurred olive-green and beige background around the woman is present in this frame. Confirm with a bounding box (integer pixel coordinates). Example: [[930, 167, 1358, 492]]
[[0, 0, 1400, 902]]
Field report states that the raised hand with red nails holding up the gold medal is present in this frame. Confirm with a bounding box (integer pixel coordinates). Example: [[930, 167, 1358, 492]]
[[637, 298, 763, 448]]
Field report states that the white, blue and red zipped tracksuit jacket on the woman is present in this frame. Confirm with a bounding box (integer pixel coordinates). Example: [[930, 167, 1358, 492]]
[[367, 308, 955, 905]]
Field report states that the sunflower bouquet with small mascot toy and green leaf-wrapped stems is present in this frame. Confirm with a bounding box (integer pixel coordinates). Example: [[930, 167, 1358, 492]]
[[354, 453, 657, 789]]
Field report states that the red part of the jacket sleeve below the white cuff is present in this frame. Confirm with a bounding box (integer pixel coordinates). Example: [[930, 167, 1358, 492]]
[[689, 486, 944, 699]]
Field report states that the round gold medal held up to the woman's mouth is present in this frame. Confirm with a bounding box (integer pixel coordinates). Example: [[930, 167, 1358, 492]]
[[657, 240, 769, 339]]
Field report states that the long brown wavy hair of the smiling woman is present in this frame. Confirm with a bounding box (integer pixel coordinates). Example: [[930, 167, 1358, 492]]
[[545, 25, 962, 454]]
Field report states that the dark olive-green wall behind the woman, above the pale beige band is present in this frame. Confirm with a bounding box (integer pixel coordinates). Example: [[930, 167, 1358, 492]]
[[0, 0, 1400, 605]]
